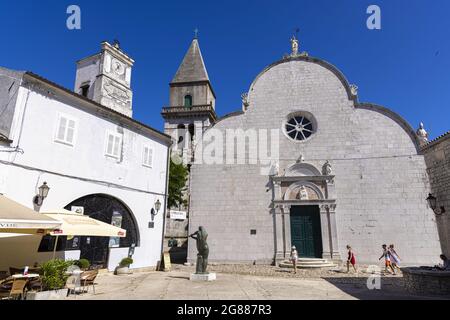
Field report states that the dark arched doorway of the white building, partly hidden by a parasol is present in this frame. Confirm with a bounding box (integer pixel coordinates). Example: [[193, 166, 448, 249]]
[[65, 194, 139, 268]]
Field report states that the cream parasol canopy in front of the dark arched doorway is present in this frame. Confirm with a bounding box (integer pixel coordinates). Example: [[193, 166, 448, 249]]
[[43, 209, 127, 238]]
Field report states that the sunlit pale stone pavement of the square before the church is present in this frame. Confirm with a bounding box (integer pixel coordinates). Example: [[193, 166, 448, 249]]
[[69, 265, 450, 300]]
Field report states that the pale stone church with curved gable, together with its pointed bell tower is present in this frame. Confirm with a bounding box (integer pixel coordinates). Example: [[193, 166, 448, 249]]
[[162, 37, 441, 265]]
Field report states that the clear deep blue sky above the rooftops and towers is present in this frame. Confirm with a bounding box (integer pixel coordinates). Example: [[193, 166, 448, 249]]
[[0, 0, 450, 138]]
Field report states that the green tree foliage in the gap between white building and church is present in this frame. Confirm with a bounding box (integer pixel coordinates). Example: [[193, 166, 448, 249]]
[[167, 159, 189, 208]]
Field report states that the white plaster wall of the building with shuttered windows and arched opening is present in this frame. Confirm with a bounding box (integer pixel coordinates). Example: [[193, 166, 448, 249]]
[[0, 84, 167, 268]]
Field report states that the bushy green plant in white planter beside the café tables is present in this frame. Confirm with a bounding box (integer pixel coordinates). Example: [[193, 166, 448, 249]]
[[27, 259, 74, 300]]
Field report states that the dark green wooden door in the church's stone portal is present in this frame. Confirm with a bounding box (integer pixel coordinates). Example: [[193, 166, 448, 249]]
[[291, 206, 322, 258]]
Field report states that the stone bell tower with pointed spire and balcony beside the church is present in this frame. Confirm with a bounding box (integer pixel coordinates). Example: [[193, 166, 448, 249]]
[[161, 35, 217, 165]]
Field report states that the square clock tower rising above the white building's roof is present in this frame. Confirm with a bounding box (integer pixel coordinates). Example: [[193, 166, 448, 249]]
[[75, 41, 134, 117]]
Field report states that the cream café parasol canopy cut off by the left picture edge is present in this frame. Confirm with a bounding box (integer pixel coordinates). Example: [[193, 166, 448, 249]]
[[0, 195, 61, 234]]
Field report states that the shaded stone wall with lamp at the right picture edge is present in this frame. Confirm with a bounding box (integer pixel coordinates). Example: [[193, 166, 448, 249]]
[[423, 133, 450, 257]]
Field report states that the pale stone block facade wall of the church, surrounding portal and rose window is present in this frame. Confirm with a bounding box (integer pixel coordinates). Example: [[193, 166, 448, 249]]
[[189, 59, 440, 264]]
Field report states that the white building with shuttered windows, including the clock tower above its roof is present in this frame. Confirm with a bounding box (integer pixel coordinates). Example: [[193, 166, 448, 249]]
[[0, 42, 171, 270]]
